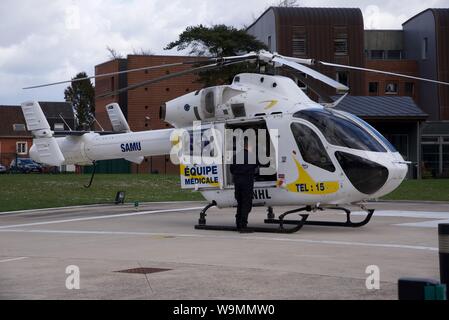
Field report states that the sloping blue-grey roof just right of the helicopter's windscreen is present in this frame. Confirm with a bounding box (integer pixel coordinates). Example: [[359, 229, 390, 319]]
[[336, 96, 428, 120]]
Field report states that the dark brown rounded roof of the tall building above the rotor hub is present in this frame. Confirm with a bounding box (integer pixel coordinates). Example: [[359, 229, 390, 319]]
[[246, 7, 363, 30]]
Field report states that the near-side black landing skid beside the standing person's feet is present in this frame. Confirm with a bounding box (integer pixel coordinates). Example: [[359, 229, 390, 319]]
[[195, 202, 309, 233]]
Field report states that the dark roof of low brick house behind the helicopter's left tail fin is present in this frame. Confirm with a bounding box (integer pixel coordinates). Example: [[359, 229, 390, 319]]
[[0, 102, 74, 137]]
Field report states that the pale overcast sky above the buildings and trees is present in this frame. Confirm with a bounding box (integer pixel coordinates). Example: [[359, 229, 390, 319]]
[[0, 0, 449, 105]]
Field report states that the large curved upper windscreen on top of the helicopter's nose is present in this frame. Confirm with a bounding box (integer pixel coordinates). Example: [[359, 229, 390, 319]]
[[295, 109, 387, 152]]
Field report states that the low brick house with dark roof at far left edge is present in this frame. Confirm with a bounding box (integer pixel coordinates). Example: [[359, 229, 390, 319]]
[[0, 102, 75, 168]]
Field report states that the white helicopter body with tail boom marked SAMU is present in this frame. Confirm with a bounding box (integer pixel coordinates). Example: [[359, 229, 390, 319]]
[[23, 74, 408, 207]]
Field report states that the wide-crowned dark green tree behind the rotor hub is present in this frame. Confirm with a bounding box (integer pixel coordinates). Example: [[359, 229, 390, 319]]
[[165, 24, 267, 86]]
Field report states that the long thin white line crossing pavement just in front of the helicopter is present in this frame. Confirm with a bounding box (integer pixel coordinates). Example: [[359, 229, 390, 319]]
[[0, 230, 438, 251]]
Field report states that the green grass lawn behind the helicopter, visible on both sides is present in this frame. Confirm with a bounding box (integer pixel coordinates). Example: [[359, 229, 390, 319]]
[[0, 174, 449, 212]]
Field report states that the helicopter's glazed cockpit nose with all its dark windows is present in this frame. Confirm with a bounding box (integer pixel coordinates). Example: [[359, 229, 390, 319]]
[[291, 108, 407, 195]]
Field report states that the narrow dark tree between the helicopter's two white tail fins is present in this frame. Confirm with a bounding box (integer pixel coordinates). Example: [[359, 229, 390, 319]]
[[64, 72, 95, 130]]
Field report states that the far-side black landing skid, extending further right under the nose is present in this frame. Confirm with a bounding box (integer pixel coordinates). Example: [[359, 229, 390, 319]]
[[265, 206, 374, 228]]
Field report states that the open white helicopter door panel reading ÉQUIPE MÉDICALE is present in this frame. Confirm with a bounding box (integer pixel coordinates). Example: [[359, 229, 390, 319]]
[[179, 124, 224, 190]]
